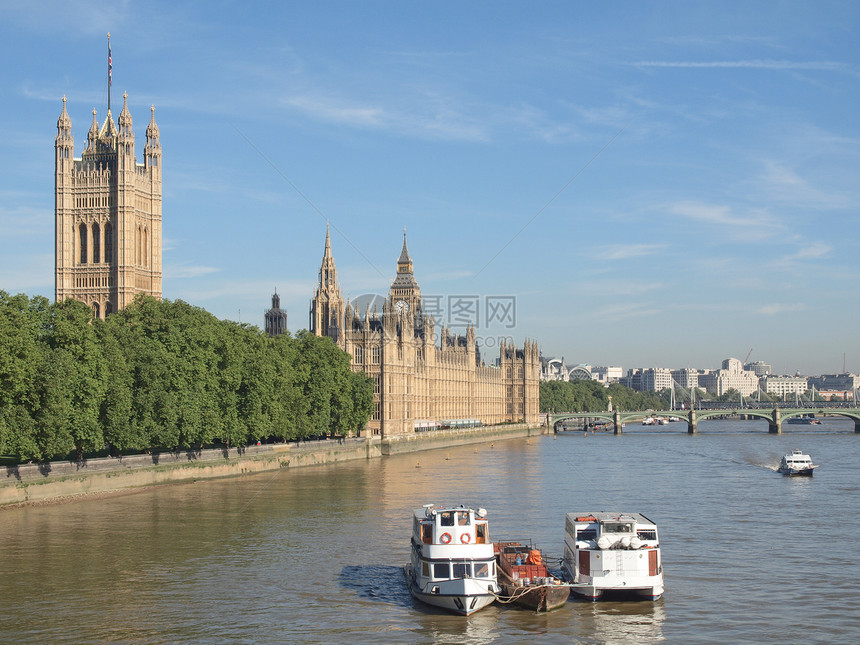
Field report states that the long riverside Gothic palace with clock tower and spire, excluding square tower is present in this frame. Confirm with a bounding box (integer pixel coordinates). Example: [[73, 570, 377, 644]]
[[310, 229, 540, 437]]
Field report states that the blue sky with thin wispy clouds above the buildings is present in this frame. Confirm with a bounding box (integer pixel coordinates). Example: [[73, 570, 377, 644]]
[[0, 0, 860, 374]]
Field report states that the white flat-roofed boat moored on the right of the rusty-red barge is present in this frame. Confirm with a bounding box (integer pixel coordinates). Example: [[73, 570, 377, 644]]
[[562, 511, 663, 600]]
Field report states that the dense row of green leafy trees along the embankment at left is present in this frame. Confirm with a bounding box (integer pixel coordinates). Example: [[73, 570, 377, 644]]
[[0, 291, 373, 461]]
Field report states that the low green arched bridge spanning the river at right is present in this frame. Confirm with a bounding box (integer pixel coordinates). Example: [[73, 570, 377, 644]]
[[546, 403, 860, 434]]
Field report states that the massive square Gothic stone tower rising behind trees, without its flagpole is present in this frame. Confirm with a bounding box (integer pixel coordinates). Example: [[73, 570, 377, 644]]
[[54, 94, 161, 318]]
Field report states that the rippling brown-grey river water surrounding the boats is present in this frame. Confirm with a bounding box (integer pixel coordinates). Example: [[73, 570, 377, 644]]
[[0, 418, 860, 644]]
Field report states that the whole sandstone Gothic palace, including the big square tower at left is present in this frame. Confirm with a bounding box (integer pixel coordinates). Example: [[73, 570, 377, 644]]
[[54, 85, 540, 436]]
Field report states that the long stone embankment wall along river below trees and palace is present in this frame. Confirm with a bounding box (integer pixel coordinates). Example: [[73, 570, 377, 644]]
[[0, 424, 542, 508]]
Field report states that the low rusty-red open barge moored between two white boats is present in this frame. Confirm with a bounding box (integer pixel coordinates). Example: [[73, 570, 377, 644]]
[[495, 542, 570, 611]]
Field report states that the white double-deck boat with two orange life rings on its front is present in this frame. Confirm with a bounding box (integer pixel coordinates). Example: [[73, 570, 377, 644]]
[[406, 504, 499, 616]]
